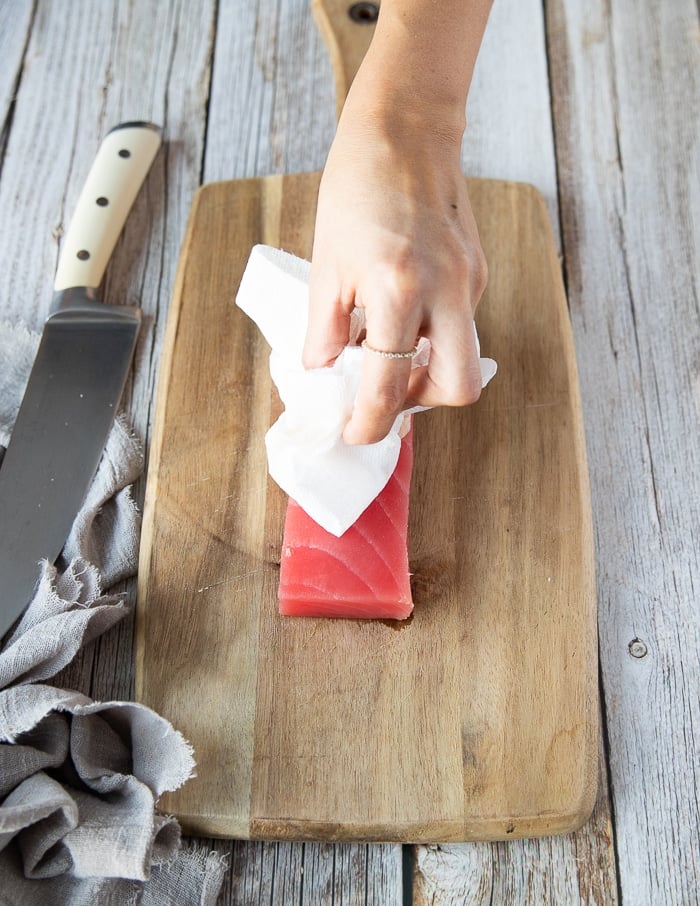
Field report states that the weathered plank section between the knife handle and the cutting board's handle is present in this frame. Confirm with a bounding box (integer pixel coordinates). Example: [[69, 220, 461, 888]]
[[204, 0, 335, 182]]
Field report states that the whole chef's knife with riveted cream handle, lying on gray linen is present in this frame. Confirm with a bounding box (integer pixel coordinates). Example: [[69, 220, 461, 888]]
[[0, 122, 161, 636]]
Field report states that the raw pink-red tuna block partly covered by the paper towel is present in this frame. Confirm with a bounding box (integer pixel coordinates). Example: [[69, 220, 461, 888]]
[[279, 430, 413, 620]]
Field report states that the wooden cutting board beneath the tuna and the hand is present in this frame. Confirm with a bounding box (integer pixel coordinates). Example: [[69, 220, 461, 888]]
[[136, 0, 598, 842]]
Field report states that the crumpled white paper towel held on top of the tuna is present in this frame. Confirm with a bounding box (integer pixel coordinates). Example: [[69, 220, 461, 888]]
[[236, 245, 496, 537]]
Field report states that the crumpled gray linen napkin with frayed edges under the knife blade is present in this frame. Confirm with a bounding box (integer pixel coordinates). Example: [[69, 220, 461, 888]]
[[0, 321, 226, 906]]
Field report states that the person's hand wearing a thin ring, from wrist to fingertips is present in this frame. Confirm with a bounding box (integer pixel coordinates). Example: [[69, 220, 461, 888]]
[[304, 62, 487, 443]]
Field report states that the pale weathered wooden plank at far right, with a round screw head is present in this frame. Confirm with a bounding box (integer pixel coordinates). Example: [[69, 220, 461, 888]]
[[547, 0, 700, 906]]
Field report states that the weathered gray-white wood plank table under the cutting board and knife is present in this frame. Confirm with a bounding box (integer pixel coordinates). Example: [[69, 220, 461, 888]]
[[0, 0, 700, 906]]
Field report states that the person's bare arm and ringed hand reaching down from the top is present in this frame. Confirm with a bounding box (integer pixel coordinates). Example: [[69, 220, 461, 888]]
[[303, 0, 490, 444]]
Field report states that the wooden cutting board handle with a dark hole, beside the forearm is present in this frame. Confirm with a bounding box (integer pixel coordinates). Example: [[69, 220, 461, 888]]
[[311, 0, 379, 117]]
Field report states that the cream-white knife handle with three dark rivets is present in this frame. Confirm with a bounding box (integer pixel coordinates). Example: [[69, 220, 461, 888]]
[[54, 123, 161, 292]]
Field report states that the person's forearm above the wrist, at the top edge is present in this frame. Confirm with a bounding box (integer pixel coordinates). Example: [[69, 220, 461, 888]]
[[350, 0, 491, 136]]
